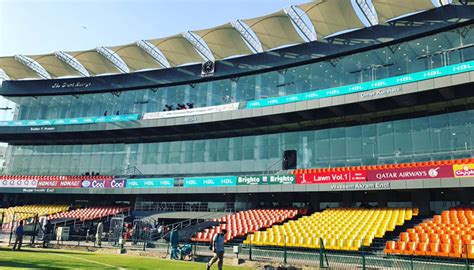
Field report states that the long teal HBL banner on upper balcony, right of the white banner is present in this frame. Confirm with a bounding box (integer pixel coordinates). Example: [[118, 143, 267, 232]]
[[245, 61, 474, 109]]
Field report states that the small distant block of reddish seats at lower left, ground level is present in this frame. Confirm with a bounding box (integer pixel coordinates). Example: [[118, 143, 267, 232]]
[[48, 206, 130, 221]]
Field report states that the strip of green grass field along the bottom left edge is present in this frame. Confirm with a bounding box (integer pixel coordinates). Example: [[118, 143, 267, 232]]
[[0, 248, 252, 270]]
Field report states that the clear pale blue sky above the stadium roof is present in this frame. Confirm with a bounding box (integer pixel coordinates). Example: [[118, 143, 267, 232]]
[[0, 0, 310, 56]]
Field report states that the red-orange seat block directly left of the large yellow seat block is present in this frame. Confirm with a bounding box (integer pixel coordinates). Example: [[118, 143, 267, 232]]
[[192, 209, 304, 243]]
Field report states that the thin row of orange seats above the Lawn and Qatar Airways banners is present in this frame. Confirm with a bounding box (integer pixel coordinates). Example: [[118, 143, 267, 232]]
[[291, 158, 474, 174]]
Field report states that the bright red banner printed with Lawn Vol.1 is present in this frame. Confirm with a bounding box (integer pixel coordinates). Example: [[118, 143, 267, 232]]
[[296, 170, 367, 184]]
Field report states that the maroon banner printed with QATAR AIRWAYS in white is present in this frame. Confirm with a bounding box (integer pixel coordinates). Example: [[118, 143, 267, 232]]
[[367, 165, 454, 181]]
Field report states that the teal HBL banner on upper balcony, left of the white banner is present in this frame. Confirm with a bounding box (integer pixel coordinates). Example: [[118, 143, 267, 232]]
[[0, 114, 140, 127]]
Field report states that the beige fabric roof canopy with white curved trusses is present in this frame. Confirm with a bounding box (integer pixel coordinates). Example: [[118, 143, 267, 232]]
[[0, 0, 449, 80]]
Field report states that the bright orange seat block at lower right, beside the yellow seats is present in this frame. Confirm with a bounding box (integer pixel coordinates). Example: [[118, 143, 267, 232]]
[[385, 208, 474, 258]]
